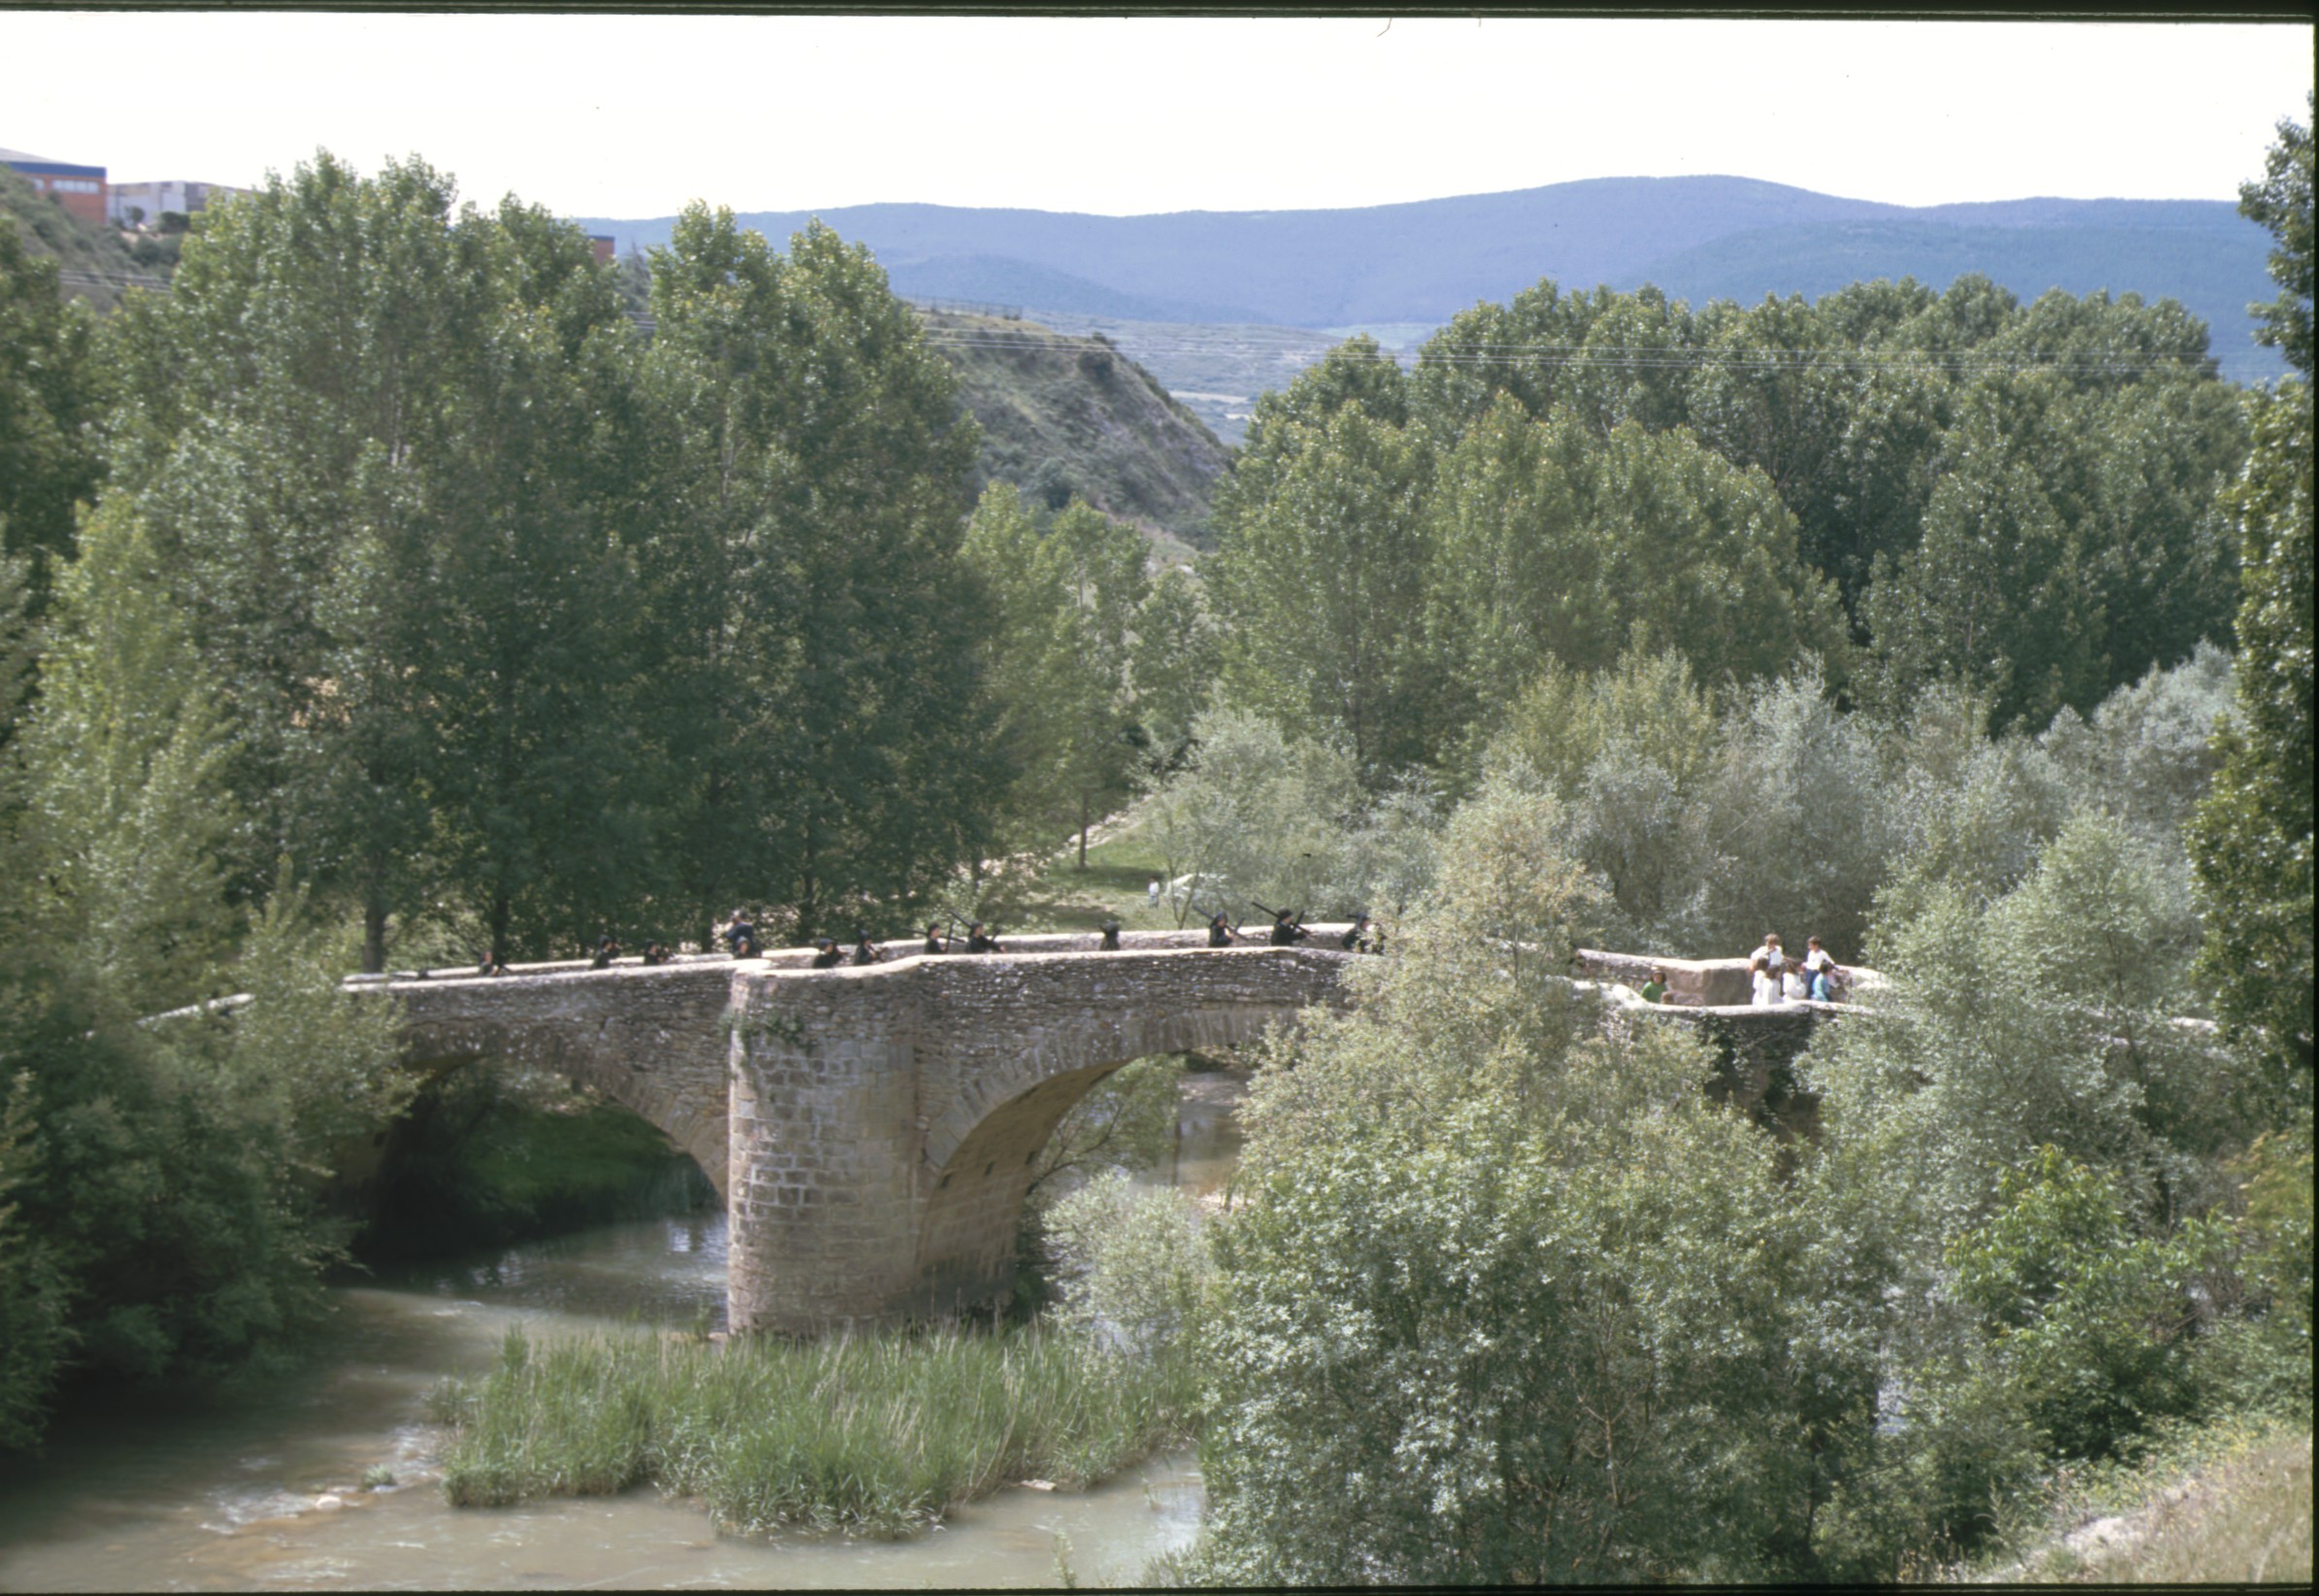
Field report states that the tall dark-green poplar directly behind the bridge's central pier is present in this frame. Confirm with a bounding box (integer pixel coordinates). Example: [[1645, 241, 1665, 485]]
[[645, 204, 1002, 935]]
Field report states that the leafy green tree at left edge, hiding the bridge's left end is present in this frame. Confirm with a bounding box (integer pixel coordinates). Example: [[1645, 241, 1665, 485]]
[[0, 494, 408, 1443]]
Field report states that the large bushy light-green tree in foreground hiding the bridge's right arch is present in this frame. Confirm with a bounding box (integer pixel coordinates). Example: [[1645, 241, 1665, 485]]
[[1192, 781, 1863, 1584]]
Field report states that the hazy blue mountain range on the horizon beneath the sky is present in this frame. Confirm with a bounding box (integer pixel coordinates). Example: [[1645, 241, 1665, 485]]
[[578, 177, 2287, 381]]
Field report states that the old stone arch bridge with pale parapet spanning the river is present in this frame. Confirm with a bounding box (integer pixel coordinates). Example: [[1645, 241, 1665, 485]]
[[366, 928, 1845, 1334]]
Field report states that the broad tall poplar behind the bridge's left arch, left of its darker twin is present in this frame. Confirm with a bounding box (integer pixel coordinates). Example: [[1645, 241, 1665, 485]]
[[100, 153, 642, 967]]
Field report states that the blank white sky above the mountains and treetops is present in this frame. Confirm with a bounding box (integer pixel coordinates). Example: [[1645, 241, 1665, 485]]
[[0, 0, 2314, 218]]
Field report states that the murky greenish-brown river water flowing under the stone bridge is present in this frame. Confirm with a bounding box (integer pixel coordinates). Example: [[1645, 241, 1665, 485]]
[[0, 1077, 1236, 1591]]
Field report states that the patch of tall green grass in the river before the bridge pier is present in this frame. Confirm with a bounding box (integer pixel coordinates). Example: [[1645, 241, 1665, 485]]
[[434, 1327, 1196, 1538]]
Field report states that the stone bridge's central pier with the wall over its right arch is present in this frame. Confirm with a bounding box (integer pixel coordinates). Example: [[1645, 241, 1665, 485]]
[[725, 940, 1347, 1334]]
